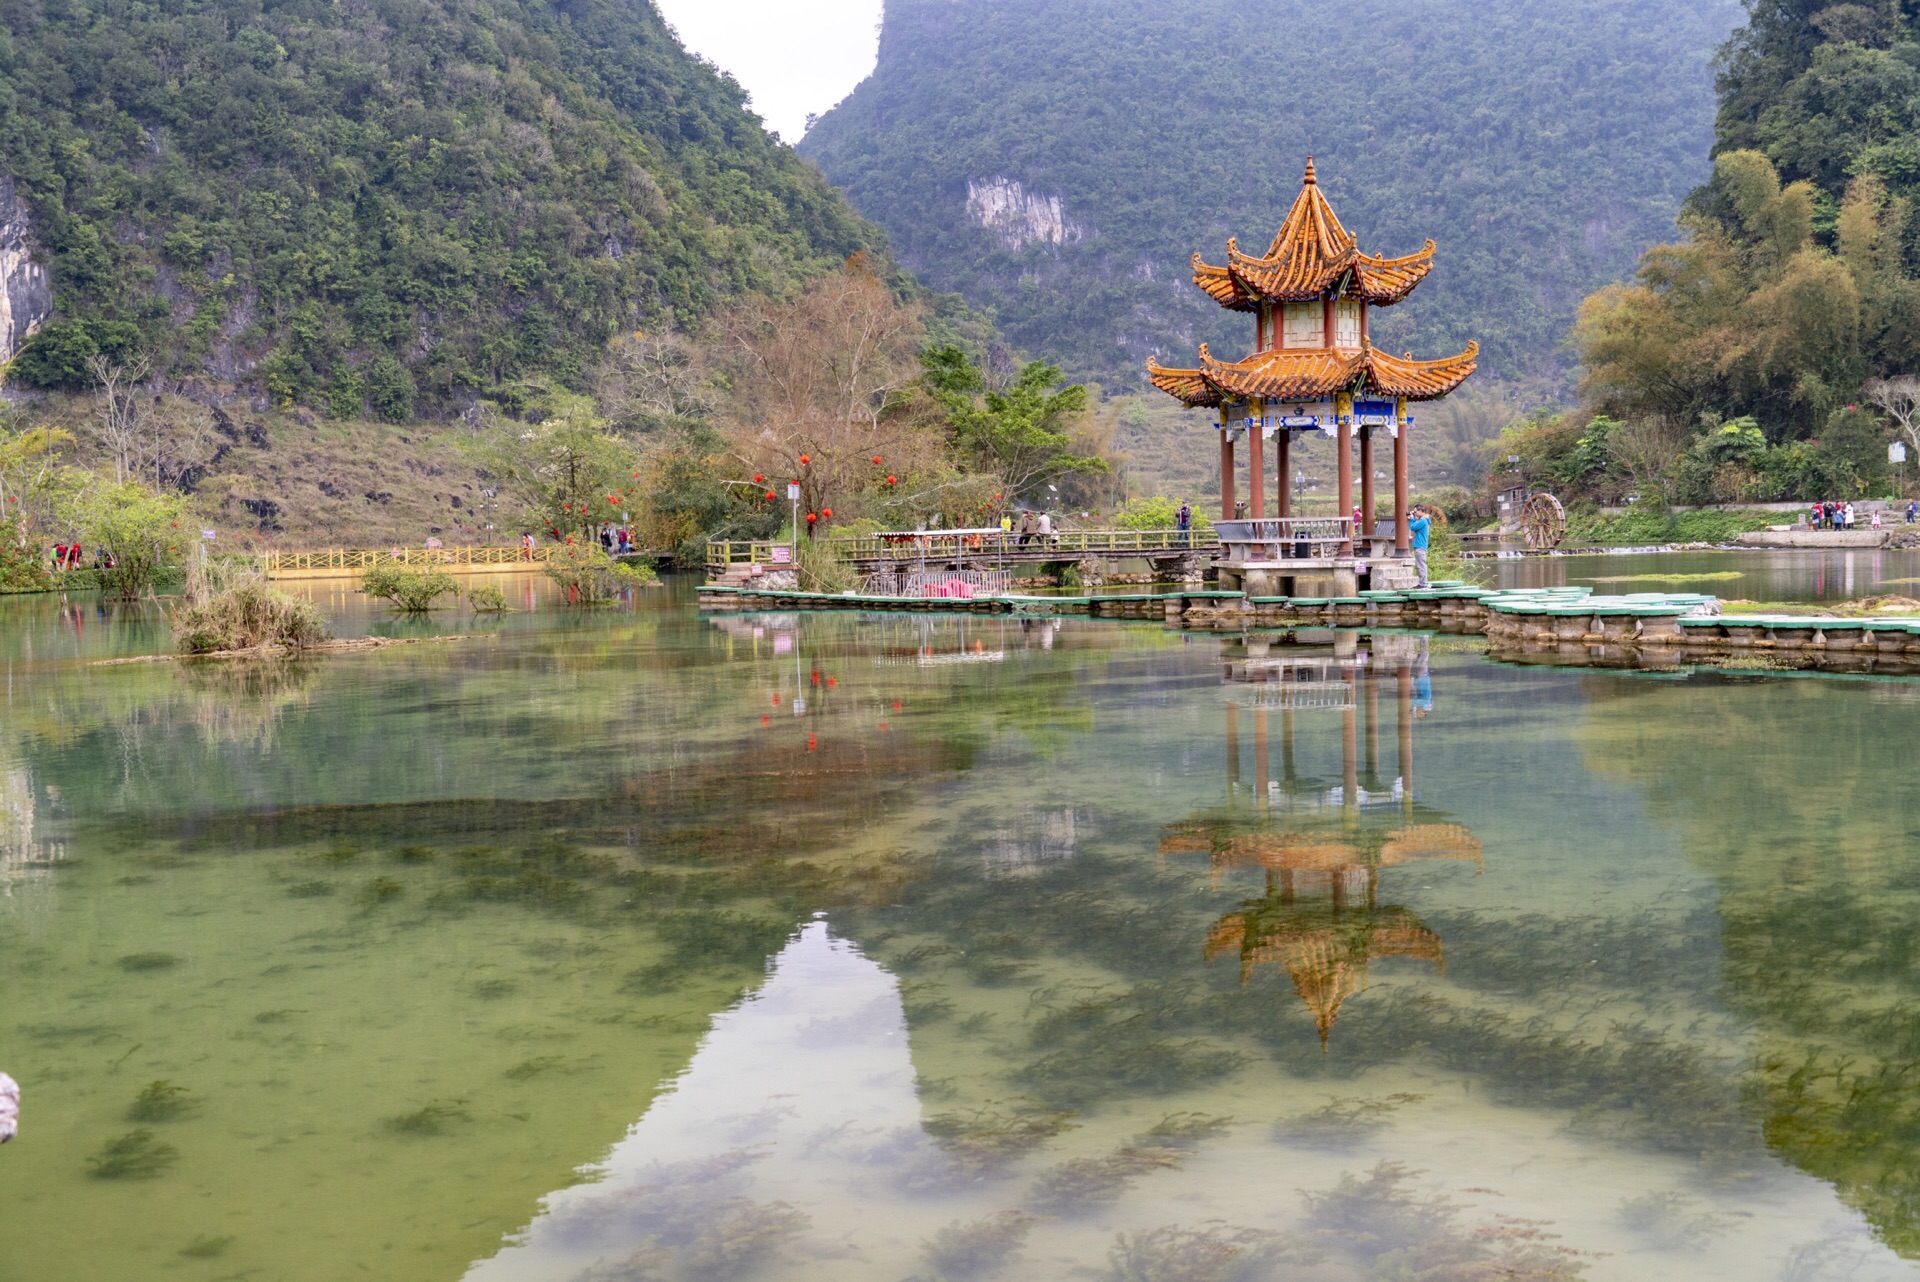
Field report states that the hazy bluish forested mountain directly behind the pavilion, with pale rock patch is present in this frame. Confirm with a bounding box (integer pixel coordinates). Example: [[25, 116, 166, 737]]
[[801, 0, 1740, 386]]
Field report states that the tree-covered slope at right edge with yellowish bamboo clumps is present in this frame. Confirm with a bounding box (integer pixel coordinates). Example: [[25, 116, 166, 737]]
[[1536, 0, 1920, 503]]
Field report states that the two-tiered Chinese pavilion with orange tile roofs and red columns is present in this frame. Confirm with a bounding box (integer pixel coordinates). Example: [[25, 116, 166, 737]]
[[1146, 157, 1480, 587]]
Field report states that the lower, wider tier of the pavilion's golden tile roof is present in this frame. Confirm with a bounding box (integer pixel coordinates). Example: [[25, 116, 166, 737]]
[[1146, 344, 1480, 407]]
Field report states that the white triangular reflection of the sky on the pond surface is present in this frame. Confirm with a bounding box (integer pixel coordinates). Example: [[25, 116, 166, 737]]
[[468, 921, 927, 1282]]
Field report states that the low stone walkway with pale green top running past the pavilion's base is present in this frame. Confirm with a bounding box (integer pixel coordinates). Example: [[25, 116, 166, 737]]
[[701, 582, 1920, 672]]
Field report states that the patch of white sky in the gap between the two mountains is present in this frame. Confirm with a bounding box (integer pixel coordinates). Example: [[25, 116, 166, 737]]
[[655, 0, 881, 142]]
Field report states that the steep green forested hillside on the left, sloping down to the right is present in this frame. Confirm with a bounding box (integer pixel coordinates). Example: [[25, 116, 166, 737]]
[[0, 0, 879, 410]]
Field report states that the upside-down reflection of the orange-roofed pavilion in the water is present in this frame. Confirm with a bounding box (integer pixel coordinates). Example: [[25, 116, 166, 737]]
[[1160, 633, 1484, 1048]]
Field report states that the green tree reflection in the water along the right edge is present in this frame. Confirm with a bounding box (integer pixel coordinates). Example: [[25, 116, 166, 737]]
[[1578, 676, 1920, 1257]]
